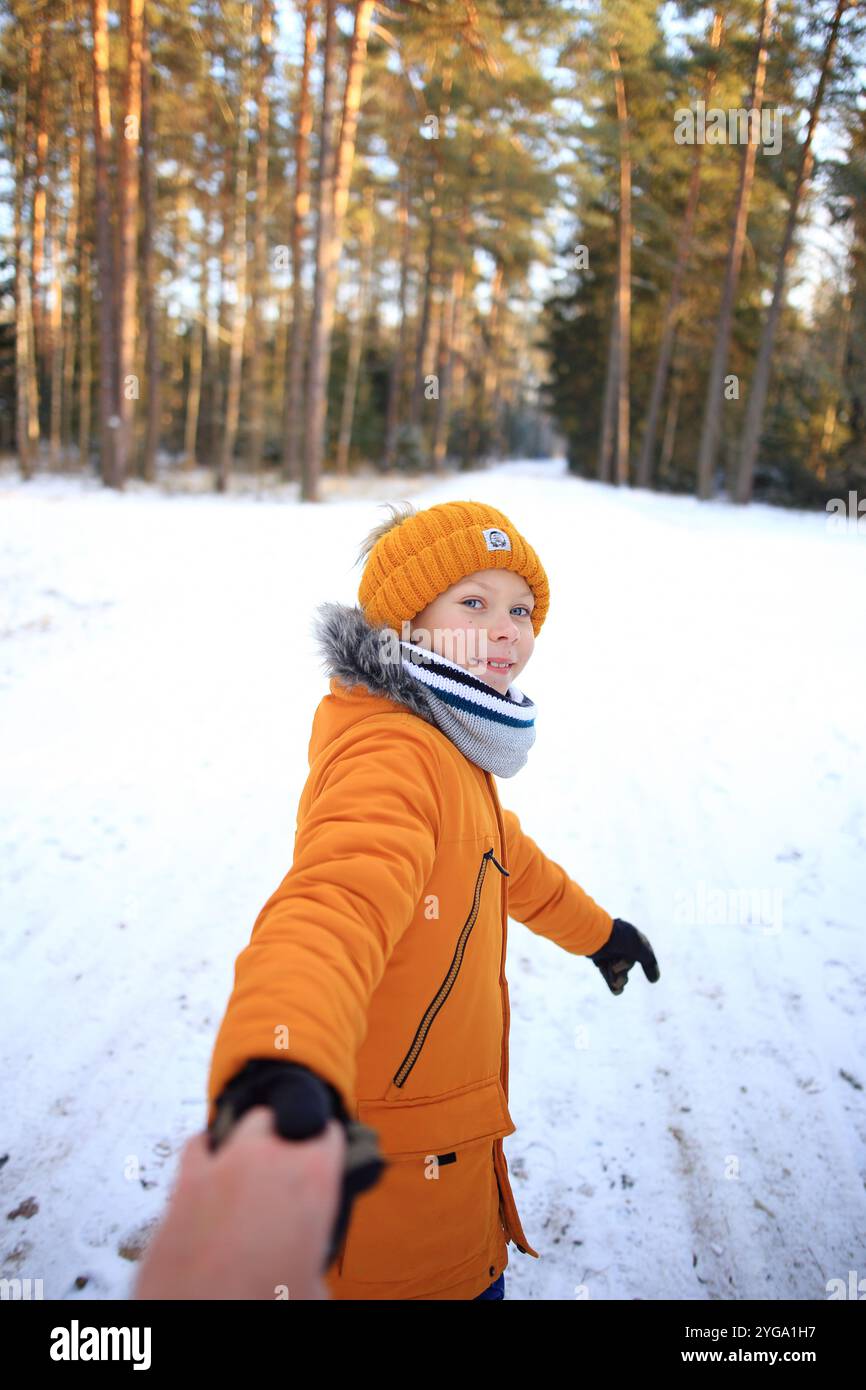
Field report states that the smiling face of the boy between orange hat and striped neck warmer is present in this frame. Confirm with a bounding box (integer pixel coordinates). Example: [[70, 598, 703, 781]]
[[409, 570, 535, 695]]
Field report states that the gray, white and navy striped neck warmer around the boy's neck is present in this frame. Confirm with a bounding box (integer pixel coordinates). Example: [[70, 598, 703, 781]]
[[400, 642, 535, 777]]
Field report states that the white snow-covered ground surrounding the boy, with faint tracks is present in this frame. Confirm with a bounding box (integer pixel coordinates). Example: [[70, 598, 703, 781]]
[[0, 463, 866, 1300]]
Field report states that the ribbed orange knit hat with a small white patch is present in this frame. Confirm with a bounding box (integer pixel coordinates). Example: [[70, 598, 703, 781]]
[[357, 502, 550, 637]]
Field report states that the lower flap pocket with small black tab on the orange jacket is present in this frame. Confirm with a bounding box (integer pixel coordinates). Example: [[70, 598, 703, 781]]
[[341, 1077, 516, 1287]]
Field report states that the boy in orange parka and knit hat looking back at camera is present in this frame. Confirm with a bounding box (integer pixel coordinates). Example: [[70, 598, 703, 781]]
[[209, 502, 659, 1298]]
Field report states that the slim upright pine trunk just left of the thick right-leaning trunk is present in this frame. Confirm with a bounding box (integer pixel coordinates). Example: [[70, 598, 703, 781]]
[[282, 0, 317, 482]]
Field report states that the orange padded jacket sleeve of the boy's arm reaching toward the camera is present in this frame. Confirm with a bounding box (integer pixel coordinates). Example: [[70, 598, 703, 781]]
[[207, 714, 442, 1125]]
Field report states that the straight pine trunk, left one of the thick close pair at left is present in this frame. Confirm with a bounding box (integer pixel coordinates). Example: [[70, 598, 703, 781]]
[[90, 0, 120, 488]]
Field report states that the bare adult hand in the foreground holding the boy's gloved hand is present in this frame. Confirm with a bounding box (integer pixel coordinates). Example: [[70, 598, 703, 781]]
[[132, 1105, 346, 1300]]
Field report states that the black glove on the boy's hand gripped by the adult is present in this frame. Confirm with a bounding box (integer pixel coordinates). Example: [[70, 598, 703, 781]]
[[209, 1058, 386, 1273]]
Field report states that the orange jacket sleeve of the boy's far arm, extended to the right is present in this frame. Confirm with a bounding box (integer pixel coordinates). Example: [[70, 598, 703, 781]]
[[502, 808, 613, 955]]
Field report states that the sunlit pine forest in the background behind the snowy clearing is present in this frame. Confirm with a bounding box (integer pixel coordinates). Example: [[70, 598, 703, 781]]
[[0, 0, 866, 510]]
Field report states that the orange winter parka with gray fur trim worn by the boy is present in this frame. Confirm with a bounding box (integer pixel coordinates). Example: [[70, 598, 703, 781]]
[[207, 605, 613, 1300]]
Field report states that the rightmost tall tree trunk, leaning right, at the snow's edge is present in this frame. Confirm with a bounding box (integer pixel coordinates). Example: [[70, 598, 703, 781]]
[[733, 0, 849, 503]]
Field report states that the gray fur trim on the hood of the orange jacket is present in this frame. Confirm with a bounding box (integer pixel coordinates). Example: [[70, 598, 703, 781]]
[[313, 603, 435, 724]]
